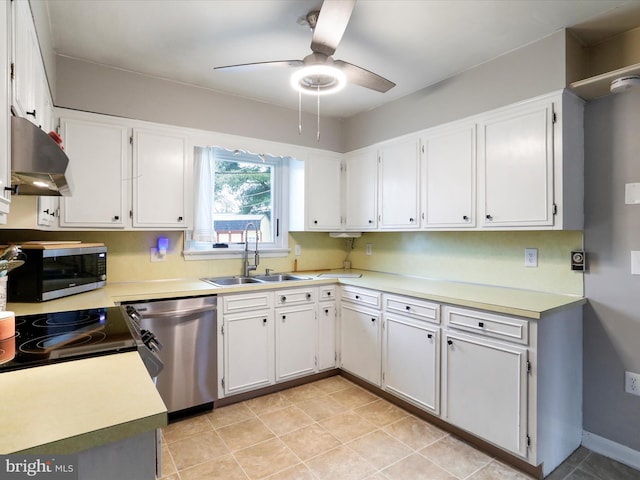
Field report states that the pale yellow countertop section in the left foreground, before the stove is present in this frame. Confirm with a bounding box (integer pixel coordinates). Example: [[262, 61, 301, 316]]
[[0, 352, 167, 454]]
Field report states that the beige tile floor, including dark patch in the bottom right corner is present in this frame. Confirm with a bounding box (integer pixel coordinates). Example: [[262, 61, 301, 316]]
[[162, 376, 640, 480]]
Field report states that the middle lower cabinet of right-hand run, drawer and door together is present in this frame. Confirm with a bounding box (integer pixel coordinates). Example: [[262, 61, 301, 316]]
[[382, 295, 440, 415]]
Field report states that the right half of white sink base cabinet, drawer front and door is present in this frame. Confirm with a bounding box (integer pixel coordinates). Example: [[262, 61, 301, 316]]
[[275, 288, 318, 381]]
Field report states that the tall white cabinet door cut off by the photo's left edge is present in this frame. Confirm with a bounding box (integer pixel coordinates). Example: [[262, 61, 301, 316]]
[[0, 2, 15, 218]]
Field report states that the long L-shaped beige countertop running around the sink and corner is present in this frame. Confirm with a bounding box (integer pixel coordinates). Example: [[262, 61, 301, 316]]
[[7, 270, 585, 319]]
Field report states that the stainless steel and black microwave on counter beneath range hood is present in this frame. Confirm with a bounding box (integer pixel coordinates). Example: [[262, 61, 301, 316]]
[[7, 242, 107, 302]]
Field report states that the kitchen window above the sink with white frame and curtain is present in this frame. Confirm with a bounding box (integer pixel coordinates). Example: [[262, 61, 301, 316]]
[[185, 147, 288, 258]]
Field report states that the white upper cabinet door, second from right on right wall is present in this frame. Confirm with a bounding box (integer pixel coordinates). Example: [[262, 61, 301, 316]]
[[422, 124, 476, 228]]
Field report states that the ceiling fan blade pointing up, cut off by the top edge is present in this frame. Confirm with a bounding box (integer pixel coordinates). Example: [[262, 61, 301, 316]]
[[311, 0, 356, 56]]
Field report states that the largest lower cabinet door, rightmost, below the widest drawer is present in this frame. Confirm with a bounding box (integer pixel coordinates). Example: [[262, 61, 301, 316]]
[[442, 331, 527, 457]]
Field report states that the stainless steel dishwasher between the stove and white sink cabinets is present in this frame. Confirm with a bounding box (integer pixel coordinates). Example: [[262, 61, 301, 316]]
[[125, 295, 218, 417]]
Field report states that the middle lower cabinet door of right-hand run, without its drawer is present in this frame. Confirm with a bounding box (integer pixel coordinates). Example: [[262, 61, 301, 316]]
[[382, 314, 440, 414]]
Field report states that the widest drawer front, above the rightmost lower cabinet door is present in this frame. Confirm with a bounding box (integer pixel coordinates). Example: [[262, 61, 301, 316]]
[[443, 306, 529, 345]]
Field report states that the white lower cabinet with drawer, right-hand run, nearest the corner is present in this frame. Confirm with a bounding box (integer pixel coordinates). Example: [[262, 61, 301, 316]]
[[340, 287, 382, 386]]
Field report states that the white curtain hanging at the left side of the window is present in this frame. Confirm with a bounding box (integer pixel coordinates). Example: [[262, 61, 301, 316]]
[[191, 147, 215, 243]]
